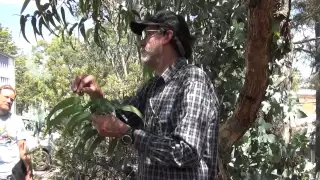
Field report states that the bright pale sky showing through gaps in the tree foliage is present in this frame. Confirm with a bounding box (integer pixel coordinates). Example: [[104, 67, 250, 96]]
[[0, 0, 314, 78]]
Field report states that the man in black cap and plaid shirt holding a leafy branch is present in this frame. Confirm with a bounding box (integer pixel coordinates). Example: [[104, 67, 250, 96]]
[[73, 11, 219, 180]]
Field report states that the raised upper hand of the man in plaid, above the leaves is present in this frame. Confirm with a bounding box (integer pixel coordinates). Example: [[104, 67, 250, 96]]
[[71, 75, 103, 98]]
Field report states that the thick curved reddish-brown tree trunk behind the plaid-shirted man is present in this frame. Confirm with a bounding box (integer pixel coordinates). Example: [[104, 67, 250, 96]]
[[218, 0, 290, 179]]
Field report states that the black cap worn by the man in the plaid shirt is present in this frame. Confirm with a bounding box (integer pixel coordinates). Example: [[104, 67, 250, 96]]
[[130, 10, 195, 58]]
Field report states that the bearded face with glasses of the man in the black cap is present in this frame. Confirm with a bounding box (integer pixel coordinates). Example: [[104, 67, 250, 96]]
[[141, 26, 163, 64]]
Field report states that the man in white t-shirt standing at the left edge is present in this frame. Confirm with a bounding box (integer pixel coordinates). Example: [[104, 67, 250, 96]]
[[0, 85, 33, 180]]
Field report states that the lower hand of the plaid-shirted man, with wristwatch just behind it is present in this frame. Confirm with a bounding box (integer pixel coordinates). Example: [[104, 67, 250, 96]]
[[91, 114, 129, 137]]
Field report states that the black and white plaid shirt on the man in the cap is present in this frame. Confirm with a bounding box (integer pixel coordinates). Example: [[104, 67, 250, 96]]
[[126, 59, 219, 180]]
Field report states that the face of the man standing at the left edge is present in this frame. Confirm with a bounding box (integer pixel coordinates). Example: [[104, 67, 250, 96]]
[[0, 89, 16, 115]]
